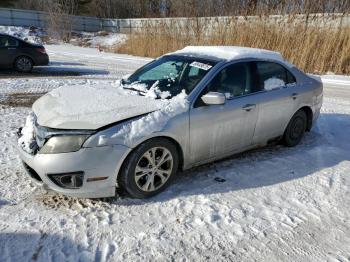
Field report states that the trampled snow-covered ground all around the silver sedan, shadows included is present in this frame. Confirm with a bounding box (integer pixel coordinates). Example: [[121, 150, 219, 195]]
[[0, 45, 350, 261]]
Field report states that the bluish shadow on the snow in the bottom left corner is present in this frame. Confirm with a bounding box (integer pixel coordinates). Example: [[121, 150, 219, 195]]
[[0, 232, 94, 261]]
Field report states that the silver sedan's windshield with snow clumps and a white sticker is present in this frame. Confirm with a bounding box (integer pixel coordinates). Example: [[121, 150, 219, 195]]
[[123, 56, 215, 98]]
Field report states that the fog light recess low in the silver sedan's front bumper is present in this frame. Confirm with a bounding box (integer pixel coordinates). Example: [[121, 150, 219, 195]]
[[48, 172, 84, 189]]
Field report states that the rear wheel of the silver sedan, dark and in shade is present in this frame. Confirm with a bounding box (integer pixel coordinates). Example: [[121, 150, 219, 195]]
[[283, 110, 307, 147]]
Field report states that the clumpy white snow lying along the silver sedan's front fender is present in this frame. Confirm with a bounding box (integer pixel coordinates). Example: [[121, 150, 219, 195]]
[[112, 90, 188, 145]]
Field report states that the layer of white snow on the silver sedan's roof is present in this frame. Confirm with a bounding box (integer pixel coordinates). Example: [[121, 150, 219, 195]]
[[172, 46, 283, 61]]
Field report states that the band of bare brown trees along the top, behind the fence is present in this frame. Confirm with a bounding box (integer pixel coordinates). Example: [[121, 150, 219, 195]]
[[10, 0, 350, 18]]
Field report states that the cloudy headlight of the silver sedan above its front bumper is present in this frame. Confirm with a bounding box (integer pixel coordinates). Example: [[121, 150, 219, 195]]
[[39, 135, 89, 154]]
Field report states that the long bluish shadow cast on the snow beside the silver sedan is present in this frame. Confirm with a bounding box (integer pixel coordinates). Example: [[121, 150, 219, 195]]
[[113, 111, 350, 205]]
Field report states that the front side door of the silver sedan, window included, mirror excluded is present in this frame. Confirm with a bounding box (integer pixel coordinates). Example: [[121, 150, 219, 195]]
[[190, 62, 258, 163]]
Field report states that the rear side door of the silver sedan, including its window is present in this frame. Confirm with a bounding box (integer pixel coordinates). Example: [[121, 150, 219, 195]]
[[253, 61, 299, 144]]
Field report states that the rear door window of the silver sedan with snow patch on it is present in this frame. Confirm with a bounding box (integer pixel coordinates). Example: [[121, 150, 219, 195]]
[[256, 61, 296, 90]]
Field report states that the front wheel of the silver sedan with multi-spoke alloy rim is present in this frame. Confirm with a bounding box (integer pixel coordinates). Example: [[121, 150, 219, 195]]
[[118, 138, 179, 198]]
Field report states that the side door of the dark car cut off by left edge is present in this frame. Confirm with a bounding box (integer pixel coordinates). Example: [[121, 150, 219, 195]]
[[0, 36, 18, 67]]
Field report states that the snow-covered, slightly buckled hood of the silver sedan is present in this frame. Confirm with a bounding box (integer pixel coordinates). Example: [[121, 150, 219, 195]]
[[33, 86, 168, 130]]
